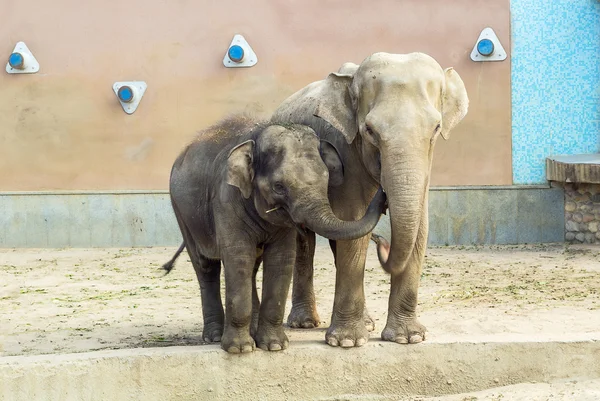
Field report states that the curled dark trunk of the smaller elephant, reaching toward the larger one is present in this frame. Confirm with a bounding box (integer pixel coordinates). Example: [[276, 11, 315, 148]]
[[291, 187, 386, 240]]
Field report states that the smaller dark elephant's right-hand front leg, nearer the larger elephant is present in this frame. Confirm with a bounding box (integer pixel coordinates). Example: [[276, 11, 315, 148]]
[[255, 231, 296, 351]]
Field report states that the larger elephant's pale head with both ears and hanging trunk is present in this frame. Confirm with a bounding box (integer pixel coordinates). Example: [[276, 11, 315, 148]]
[[314, 53, 469, 273]]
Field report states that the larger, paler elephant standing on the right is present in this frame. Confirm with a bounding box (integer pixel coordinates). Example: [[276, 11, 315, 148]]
[[271, 53, 469, 347]]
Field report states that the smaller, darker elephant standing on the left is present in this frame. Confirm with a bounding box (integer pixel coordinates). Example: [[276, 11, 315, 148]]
[[165, 117, 385, 353]]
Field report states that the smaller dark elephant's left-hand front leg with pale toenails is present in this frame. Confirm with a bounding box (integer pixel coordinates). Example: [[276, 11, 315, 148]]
[[221, 239, 256, 353]]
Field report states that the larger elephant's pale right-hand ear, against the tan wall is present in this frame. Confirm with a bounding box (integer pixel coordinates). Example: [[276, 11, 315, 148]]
[[442, 67, 469, 140]]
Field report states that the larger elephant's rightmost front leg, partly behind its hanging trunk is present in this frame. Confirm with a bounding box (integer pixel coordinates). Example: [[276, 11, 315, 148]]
[[381, 214, 428, 344]]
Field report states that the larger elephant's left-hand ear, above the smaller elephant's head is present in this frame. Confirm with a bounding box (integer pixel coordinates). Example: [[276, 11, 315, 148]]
[[313, 72, 358, 143]]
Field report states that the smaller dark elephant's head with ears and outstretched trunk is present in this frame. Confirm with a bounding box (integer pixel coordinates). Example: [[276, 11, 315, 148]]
[[227, 125, 385, 240]]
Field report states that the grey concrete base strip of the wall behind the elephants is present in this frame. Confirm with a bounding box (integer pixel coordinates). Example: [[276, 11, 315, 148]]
[[0, 186, 565, 248]]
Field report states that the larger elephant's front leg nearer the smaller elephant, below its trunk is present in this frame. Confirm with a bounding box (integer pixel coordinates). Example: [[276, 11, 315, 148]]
[[325, 235, 370, 347]]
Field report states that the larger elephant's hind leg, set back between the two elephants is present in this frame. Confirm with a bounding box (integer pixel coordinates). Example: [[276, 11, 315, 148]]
[[287, 231, 321, 329]]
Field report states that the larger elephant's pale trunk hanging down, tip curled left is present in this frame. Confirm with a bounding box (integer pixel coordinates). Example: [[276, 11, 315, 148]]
[[377, 152, 428, 274]]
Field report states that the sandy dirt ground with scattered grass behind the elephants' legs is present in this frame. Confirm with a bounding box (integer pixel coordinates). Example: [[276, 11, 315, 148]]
[[0, 244, 600, 356]]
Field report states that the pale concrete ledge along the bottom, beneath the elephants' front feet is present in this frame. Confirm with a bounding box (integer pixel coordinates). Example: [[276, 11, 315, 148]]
[[0, 340, 600, 401]]
